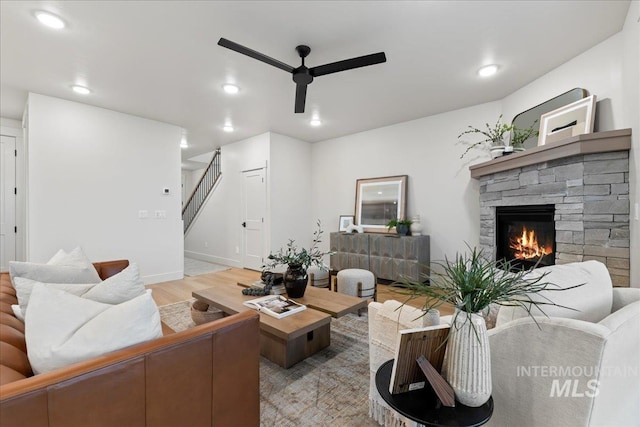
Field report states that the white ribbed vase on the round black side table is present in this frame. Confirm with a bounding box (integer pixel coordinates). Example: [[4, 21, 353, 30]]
[[443, 310, 491, 407]]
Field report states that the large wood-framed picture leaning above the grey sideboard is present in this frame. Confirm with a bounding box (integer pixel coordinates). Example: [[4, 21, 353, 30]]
[[355, 175, 407, 233]]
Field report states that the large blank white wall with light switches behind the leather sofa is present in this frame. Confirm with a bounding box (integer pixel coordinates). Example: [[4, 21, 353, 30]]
[[27, 93, 183, 283]]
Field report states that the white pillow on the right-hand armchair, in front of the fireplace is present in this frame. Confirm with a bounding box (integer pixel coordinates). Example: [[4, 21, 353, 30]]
[[496, 261, 613, 326]]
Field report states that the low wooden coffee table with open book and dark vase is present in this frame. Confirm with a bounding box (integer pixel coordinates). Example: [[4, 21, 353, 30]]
[[192, 283, 367, 368]]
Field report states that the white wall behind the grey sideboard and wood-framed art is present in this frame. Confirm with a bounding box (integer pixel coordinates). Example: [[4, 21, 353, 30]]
[[312, 102, 500, 261]]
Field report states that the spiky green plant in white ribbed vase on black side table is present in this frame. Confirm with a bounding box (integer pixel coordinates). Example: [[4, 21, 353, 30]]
[[395, 244, 582, 407]]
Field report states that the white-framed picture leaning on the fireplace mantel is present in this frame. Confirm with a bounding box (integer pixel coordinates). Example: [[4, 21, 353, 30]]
[[538, 95, 596, 145]]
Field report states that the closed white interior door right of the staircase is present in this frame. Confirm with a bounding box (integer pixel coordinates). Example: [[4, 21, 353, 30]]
[[242, 169, 267, 270]]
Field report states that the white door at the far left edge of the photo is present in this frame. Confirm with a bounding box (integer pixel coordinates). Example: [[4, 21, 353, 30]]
[[0, 135, 16, 271]]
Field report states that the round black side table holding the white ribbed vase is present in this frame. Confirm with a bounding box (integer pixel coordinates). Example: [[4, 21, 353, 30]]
[[376, 359, 493, 427]]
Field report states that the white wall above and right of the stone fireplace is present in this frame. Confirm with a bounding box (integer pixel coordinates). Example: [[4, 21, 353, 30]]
[[502, 2, 640, 287]]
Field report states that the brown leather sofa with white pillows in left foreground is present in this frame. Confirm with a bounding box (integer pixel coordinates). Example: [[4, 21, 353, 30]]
[[0, 261, 260, 427]]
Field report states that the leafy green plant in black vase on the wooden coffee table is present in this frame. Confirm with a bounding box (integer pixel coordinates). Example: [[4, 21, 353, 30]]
[[263, 220, 334, 298]]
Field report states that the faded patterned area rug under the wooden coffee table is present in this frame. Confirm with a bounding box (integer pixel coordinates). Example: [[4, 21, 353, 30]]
[[160, 300, 378, 427]]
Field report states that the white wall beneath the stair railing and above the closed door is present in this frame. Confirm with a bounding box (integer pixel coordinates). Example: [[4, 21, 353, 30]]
[[184, 133, 270, 267]]
